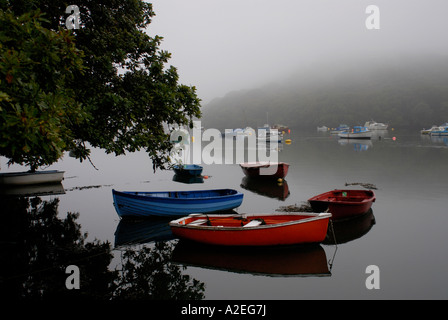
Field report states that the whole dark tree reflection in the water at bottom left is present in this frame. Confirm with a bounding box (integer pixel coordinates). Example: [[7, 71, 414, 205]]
[[0, 194, 205, 304]]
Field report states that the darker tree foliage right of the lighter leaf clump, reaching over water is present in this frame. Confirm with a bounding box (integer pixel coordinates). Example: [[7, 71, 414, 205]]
[[0, 0, 201, 168]]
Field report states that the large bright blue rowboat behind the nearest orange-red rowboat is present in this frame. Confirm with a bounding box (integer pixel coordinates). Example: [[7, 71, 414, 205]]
[[112, 189, 243, 217]]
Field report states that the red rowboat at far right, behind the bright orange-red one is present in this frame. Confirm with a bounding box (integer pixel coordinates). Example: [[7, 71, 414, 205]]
[[308, 190, 375, 219]]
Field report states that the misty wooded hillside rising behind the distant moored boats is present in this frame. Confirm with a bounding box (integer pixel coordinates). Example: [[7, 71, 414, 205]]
[[201, 57, 448, 130]]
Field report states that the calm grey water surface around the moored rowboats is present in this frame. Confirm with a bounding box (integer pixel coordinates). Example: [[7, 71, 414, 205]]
[[1, 130, 448, 300]]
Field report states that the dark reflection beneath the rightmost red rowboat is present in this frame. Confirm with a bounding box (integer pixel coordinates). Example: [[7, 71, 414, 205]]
[[322, 209, 376, 244]]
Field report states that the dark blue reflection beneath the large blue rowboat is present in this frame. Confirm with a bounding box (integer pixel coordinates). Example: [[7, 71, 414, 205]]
[[115, 218, 174, 247]]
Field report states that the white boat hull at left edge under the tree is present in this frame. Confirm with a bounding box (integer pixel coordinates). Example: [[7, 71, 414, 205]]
[[0, 170, 64, 186]]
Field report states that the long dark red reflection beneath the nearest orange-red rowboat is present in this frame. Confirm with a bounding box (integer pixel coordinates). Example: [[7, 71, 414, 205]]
[[172, 240, 331, 277]]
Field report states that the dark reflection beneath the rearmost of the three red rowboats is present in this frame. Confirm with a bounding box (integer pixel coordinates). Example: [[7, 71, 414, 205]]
[[241, 177, 289, 200]]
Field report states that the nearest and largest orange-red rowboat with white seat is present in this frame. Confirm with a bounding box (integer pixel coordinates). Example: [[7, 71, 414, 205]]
[[170, 212, 331, 246]]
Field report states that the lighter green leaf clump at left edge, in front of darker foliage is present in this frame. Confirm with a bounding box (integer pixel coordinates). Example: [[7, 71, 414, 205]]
[[0, 11, 87, 169]]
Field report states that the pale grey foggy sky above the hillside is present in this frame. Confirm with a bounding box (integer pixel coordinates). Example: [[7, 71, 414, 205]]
[[147, 0, 448, 104]]
